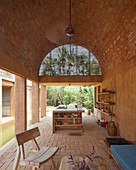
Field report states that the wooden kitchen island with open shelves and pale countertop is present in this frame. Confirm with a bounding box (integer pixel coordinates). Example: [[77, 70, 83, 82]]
[[52, 108, 84, 133]]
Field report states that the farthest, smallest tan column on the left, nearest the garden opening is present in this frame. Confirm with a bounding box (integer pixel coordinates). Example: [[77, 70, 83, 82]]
[[40, 85, 46, 117]]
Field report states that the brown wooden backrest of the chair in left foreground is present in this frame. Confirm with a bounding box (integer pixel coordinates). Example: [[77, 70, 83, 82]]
[[16, 127, 40, 145]]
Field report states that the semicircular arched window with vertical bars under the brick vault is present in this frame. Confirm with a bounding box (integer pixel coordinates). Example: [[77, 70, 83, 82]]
[[39, 44, 102, 76]]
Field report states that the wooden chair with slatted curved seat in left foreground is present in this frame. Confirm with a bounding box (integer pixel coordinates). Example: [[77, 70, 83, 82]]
[[13, 127, 58, 170]]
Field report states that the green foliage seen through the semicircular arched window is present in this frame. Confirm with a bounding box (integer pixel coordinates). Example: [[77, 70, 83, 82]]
[[42, 47, 101, 76]]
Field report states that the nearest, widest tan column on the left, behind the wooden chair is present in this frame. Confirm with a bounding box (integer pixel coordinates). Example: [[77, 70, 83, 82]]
[[15, 76, 27, 133]]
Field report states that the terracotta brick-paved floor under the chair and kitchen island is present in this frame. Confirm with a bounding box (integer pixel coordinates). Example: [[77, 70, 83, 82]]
[[0, 113, 119, 170]]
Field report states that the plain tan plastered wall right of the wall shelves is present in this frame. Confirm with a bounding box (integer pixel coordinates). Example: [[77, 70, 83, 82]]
[[102, 56, 136, 141]]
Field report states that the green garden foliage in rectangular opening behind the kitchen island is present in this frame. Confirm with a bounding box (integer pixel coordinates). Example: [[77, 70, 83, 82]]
[[47, 86, 94, 112]]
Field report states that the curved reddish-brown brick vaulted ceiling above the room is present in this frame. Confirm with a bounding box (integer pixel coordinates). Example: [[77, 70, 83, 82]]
[[0, 0, 136, 80]]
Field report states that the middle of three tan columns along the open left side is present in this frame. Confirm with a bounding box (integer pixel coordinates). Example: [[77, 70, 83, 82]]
[[32, 82, 39, 123]]
